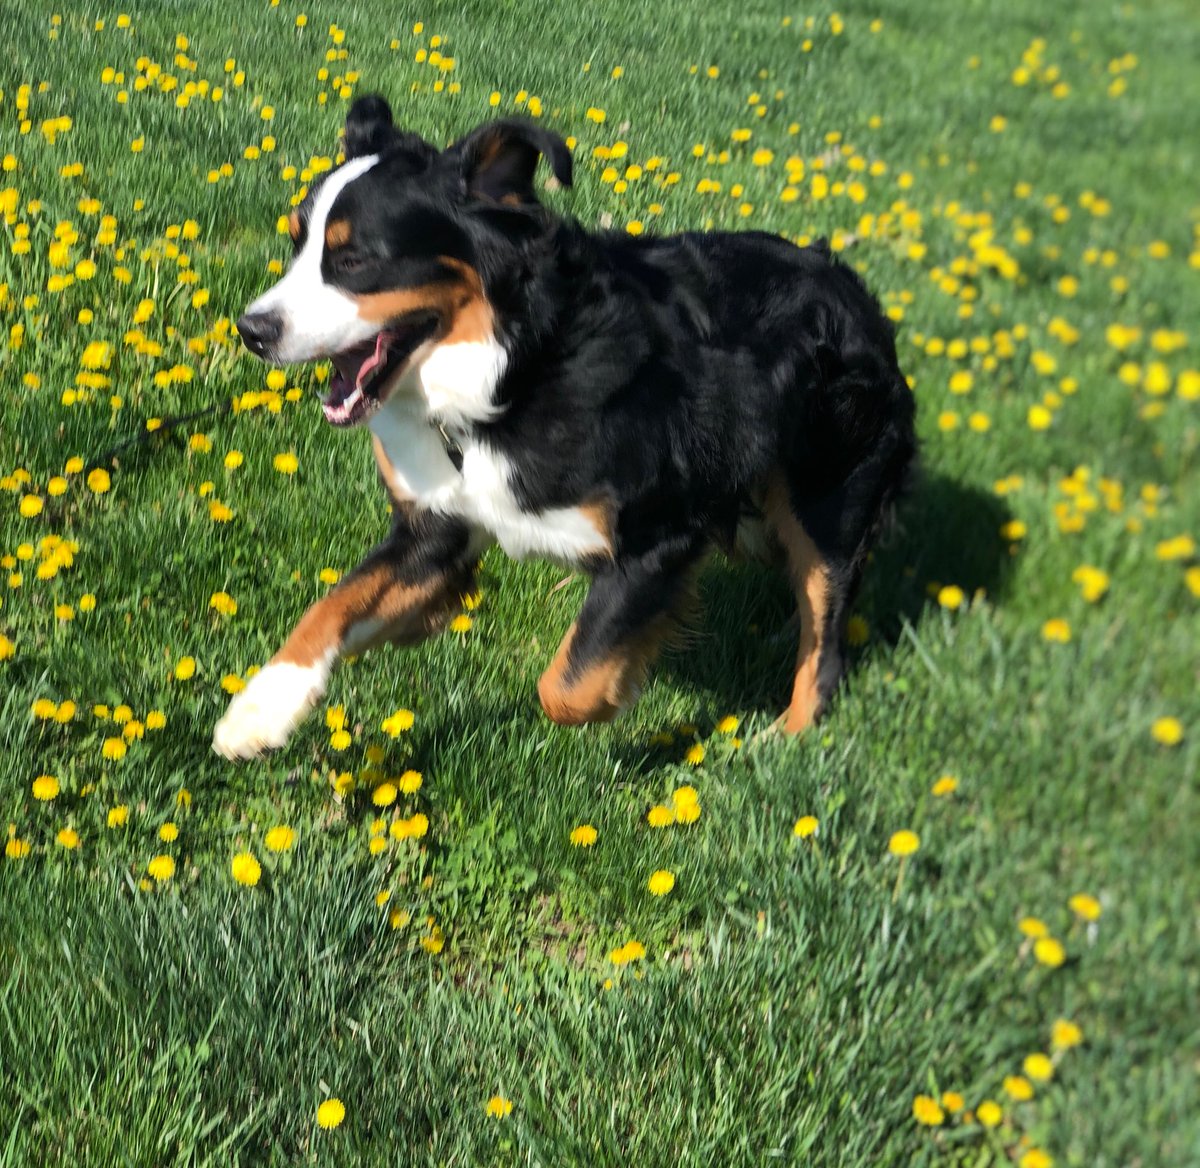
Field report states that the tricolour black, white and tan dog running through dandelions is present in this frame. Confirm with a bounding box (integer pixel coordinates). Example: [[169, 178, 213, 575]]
[[214, 96, 916, 759]]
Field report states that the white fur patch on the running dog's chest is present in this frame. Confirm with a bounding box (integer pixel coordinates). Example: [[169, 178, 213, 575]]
[[370, 401, 610, 564]]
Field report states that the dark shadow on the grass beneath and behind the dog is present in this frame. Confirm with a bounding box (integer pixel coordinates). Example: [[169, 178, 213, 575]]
[[659, 473, 1013, 717]]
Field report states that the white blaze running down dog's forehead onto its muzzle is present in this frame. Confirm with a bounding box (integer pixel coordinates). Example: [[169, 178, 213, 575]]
[[246, 154, 379, 361]]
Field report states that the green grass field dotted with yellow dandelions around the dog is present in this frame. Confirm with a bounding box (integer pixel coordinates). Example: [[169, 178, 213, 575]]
[[0, 0, 1200, 1168]]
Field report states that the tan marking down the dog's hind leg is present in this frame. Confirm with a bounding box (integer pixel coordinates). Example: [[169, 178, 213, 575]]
[[764, 478, 829, 733]]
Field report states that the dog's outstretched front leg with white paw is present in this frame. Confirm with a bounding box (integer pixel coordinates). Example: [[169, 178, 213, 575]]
[[212, 508, 479, 759]]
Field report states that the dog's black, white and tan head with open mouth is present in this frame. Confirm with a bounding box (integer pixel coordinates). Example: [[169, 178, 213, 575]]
[[238, 97, 571, 426]]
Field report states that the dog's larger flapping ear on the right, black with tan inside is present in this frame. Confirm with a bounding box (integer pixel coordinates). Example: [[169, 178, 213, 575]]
[[446, 118, 571, 204]]
